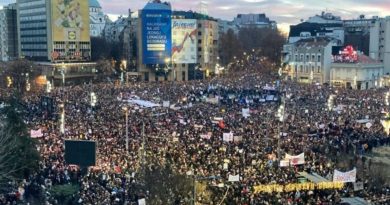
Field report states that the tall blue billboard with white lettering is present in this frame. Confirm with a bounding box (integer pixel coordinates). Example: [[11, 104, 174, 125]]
[[141, 10, 172, 64]]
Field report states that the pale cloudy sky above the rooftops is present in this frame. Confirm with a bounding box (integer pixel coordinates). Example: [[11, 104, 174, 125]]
[[0, 0, 390, 32]]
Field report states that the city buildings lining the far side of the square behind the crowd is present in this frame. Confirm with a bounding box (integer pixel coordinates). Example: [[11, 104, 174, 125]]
[[0, 0, 390, 88]]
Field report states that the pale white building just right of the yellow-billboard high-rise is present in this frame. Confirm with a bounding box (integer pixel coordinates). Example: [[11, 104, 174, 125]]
[[89, 0, 108, 37]]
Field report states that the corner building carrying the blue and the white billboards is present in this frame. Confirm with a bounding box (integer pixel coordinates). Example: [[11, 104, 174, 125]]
[[136, 2, 219, 81]]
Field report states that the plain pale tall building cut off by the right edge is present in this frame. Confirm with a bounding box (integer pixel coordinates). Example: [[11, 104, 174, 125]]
[[370, 16, 390, 74]]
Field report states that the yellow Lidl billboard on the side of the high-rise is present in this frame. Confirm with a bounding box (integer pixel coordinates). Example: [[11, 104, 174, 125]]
[[51, 0, 89, 42]]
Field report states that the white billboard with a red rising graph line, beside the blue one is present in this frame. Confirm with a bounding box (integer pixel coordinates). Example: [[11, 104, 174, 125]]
[[172, 19, 198, 64]]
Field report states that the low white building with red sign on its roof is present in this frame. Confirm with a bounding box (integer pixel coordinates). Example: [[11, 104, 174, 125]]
[[330, 48, 383, 90]]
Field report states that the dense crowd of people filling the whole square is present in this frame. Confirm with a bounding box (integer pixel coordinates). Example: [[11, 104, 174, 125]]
[[0, 60, 390, 205]]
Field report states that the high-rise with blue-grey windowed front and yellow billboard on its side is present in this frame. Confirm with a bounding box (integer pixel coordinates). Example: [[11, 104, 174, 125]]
[[17, 0, 91, 62]]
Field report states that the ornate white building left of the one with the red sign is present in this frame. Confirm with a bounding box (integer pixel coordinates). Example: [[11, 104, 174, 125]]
[[283, 37, 338, 84]]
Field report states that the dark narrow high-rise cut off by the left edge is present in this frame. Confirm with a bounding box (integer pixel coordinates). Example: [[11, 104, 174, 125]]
[[0, 4, 18, 61]]
